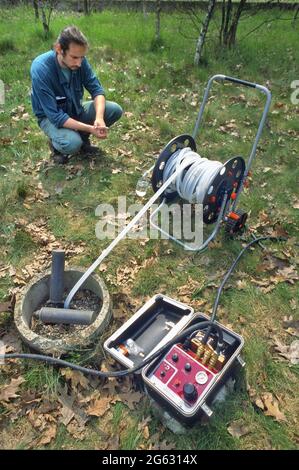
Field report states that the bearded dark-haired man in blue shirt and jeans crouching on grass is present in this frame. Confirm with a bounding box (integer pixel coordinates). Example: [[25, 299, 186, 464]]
[[30, 26, 122, 164]]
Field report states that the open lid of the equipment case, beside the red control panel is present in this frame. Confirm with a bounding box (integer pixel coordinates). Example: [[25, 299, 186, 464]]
[[104, 294, 194, 373]]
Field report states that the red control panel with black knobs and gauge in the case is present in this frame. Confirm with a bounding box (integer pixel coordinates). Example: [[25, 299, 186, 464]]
[[150, 344, 216, 408]]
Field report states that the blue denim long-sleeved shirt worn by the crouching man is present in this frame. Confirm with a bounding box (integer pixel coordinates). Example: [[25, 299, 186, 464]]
[[30, 51, 105, 128]]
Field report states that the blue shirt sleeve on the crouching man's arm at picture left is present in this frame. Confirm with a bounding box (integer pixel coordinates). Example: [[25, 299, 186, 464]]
[[32, 74, 70, 128]]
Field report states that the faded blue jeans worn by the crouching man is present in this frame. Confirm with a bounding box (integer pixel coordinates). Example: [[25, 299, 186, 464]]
[[39, 101, 123, 155]]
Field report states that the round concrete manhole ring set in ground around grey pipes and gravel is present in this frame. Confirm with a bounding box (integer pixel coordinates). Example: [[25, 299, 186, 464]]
[[14, 268, 112, 356]]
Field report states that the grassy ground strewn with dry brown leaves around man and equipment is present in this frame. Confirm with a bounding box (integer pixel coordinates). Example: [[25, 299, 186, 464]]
[[0, 8, 299, 450]]
